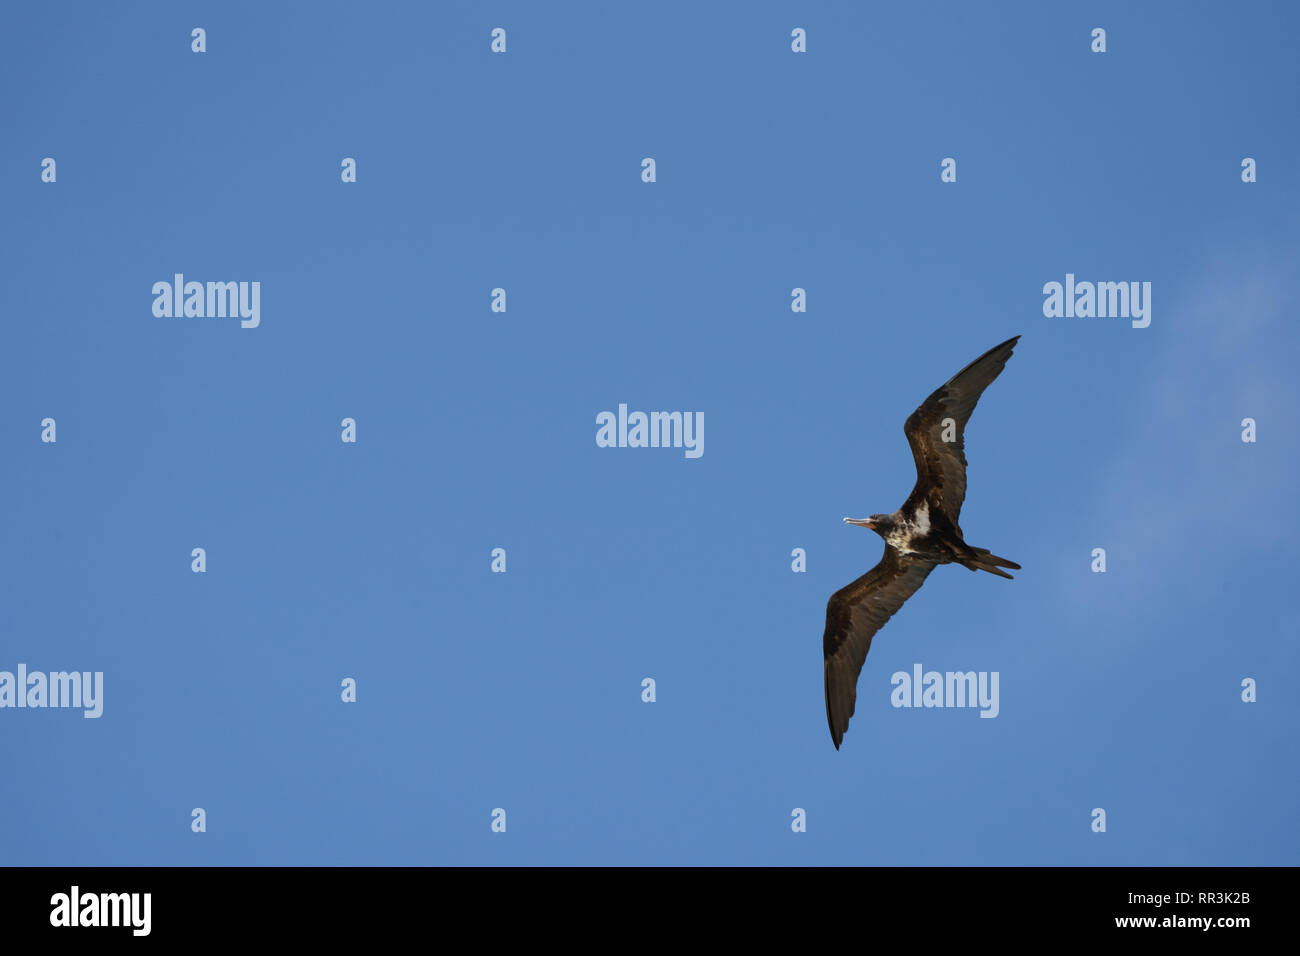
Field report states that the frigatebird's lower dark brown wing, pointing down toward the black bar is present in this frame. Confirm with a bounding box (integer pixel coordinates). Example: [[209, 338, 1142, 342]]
[[822, 545, 935, 750]]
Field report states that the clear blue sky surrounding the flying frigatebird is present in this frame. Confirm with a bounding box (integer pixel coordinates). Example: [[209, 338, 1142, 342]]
[[0, 3, 1300, 865]]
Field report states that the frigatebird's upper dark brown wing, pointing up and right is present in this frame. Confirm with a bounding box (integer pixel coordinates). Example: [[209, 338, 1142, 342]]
[[902, 336, 1021, 535]]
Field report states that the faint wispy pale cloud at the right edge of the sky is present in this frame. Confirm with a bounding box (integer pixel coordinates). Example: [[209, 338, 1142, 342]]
[[1060, 254, 1300, 613]]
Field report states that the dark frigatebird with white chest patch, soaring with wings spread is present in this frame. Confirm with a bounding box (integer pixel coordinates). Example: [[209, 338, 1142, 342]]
[[822, 336, 1021, 750]]
